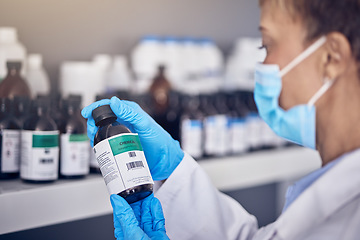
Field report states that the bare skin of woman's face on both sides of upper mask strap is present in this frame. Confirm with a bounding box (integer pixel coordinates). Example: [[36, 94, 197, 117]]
[[260, 1, 324, 110]]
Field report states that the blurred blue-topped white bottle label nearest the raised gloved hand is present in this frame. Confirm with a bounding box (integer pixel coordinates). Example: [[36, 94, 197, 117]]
[[181, 119, 203, 158]]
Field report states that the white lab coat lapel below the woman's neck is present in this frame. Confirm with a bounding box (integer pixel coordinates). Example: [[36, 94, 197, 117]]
[[267, 149, 360, 239]]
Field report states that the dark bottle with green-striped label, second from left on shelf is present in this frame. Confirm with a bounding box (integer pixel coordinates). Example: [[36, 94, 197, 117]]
[[20, 98, 59, 183]]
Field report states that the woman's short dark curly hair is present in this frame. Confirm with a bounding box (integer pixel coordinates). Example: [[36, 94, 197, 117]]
[[259, 0, 360, 74]]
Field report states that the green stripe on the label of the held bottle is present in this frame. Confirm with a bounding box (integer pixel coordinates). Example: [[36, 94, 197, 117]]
[[109, 135, 142, 156]]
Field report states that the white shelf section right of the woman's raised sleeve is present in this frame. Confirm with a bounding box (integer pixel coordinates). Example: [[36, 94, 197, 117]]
[[200, 147, 321, 191]]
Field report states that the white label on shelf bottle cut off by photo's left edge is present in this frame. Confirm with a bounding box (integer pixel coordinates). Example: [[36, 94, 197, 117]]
[[1, 130, 20, 173]]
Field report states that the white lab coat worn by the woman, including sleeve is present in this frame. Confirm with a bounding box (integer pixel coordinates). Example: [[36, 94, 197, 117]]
[[155, 149, 360, 240]]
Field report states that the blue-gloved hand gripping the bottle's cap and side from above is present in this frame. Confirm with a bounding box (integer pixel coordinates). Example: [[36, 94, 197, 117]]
[[81, 97, 184, 181]]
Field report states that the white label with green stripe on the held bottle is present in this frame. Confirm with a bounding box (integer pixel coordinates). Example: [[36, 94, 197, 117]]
[[94, 133, 154, 195]]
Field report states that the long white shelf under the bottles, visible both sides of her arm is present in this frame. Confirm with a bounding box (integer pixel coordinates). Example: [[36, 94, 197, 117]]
[[0, 147, 320, 234]]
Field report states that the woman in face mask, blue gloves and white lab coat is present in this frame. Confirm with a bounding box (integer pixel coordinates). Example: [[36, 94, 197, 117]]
[[83, 0, 360, 240]]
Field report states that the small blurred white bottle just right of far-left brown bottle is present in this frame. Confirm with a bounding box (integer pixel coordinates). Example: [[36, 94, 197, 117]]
[[26, 54, 50, 97]]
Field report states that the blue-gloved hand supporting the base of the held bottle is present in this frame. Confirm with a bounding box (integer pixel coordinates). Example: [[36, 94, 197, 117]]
[[110, 194, 169, 240]]
